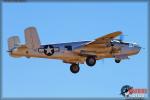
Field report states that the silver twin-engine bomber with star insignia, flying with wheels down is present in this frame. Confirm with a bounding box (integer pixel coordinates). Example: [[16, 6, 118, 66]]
[[8, 27, 141, 73]]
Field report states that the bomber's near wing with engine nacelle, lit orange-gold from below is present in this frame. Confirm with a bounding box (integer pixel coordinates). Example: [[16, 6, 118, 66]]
[[74, 31, 122, 59]]
